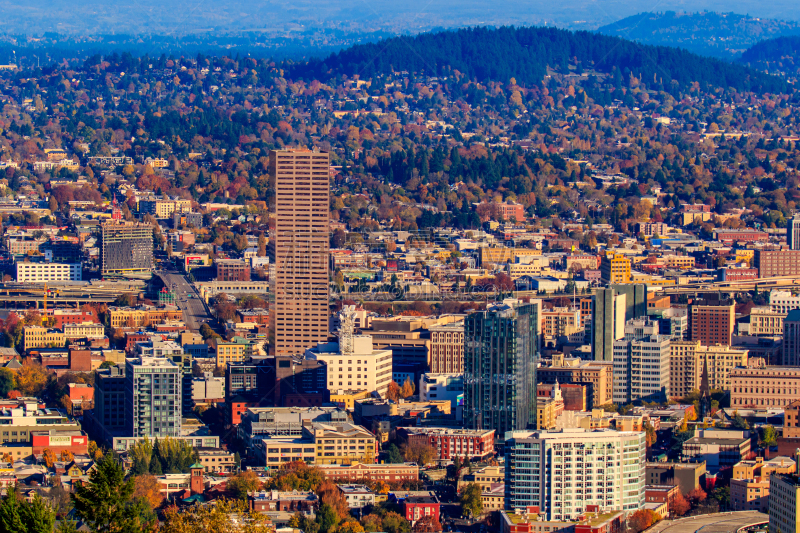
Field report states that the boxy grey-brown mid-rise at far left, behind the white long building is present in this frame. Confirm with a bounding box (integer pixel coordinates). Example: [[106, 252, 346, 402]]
[[100, 222, 153, 276]]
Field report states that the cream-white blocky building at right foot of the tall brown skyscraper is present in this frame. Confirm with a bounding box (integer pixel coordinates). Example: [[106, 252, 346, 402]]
[[306, 334, 392, 396]]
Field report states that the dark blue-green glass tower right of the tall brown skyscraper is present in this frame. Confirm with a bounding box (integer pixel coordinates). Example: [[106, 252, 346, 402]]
[[464, 300, 542, 440]]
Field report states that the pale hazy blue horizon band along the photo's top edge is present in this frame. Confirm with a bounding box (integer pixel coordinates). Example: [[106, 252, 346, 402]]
[[0, 0, 800, 35]]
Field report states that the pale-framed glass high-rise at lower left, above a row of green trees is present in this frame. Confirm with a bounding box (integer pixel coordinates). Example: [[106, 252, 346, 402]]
[[125, 357, 182, 438]]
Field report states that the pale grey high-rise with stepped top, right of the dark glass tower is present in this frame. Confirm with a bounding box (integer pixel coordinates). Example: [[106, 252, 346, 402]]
[[613, 318, 670, 404]]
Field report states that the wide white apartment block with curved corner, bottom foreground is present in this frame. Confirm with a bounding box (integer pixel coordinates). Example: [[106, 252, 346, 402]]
[[505, 428, 646, 520]]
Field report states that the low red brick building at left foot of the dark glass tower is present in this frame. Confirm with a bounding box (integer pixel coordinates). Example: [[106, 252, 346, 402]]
[[397, 427, 494, 460]]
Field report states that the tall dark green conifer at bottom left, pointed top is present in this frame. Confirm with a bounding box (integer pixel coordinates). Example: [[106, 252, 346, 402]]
[[72, 454, 149, 533]]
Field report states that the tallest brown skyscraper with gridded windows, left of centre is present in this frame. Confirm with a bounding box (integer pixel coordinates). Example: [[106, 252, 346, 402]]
[[268, 150, 330, 355]]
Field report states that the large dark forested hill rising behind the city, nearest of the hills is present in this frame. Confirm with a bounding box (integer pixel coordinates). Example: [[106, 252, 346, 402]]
[[286, 27, 787, 93]]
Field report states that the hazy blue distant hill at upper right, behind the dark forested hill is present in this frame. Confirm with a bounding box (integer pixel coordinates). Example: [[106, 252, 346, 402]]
[[597, 11, 800, 60]]
